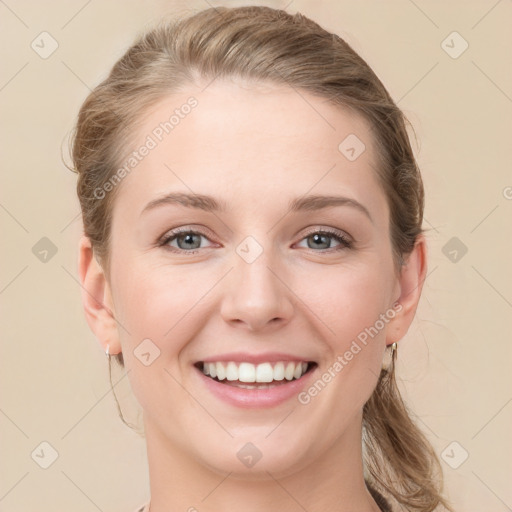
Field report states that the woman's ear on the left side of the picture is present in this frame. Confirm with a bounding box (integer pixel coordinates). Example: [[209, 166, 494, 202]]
[[78, 235, 121, 354]]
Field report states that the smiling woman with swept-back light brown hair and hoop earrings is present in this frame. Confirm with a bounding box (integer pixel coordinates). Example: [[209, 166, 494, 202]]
[[68, 7, 450, 512]]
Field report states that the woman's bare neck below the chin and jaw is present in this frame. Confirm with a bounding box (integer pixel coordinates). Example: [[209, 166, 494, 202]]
[[144, 417, 380, 512]]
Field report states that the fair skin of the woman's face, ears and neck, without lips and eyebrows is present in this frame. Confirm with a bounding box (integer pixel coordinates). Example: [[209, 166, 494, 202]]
[[79, 80, 426, 512]]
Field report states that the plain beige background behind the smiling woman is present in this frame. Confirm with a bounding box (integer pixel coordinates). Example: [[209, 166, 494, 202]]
[[0, 0, 512, 512]]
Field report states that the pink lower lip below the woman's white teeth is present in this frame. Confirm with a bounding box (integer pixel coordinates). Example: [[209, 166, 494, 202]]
[[194, 367, 316, 408]]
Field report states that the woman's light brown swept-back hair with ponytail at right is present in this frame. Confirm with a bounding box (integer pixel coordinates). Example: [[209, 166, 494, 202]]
[[67, 6, 452, 512]]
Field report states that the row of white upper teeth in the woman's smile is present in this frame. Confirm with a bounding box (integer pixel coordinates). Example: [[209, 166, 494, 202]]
[[203, 361, 308, 387]]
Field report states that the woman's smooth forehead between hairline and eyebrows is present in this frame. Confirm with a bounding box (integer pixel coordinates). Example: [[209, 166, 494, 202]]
[[110, 80, 385, 222]]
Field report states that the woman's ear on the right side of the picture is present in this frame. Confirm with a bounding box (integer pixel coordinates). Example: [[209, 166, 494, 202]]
[[386, 235, 427, 345]]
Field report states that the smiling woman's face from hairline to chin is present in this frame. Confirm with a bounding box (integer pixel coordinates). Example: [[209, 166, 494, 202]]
[[81, 81, 424, 475]]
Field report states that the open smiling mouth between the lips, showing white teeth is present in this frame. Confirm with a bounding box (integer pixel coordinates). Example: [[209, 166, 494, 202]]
[[194, 361, 317, 390]]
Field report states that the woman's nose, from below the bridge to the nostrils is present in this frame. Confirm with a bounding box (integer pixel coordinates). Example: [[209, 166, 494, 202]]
[[221, 251, 294, 331]]
